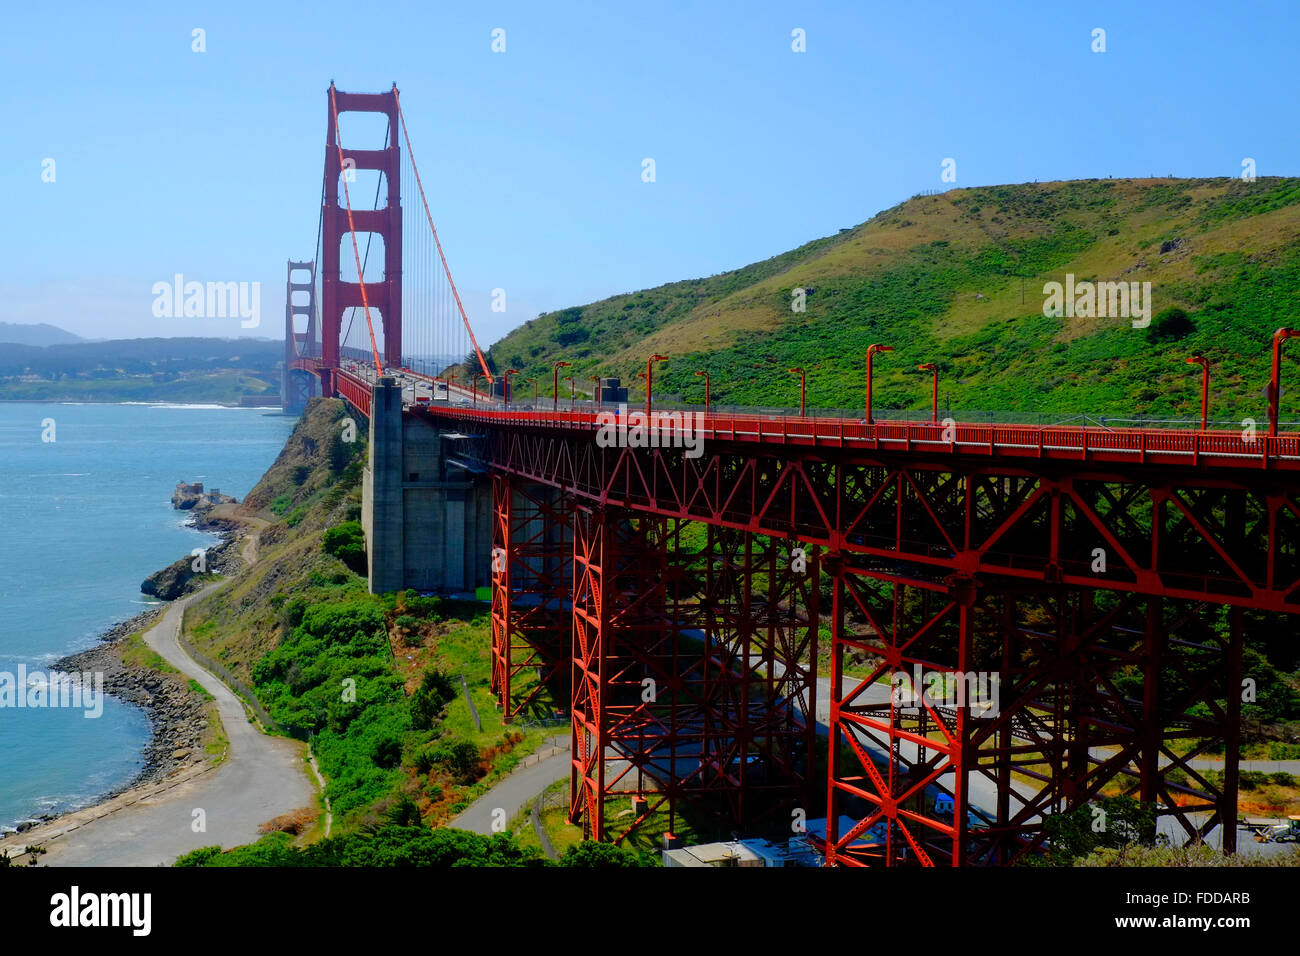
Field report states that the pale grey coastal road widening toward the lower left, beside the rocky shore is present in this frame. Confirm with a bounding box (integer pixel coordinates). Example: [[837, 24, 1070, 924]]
[[12, 538, 316, 866]]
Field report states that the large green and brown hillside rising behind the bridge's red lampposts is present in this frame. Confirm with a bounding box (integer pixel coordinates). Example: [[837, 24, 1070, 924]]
[[490, 178, 1300, 420]]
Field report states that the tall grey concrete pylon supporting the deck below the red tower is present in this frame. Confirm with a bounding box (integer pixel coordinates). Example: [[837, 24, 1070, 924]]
[[361, 378, 491, 594]]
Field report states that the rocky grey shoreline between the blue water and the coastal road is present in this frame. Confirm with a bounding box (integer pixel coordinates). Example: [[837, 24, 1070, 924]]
[[0, 485, 242, 838]]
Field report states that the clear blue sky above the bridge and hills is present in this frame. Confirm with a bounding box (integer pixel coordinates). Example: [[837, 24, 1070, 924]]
[[0, 0, 1300, 343]]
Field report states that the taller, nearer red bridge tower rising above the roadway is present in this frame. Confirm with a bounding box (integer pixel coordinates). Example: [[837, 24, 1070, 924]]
[[320, 83, 402, 397]]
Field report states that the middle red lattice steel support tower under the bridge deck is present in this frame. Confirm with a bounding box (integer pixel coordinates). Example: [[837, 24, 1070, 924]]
[[569, 507, 818, 842]]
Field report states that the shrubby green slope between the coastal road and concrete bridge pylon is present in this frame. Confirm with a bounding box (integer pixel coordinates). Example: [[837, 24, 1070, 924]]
[[186, 398, 564, 832]]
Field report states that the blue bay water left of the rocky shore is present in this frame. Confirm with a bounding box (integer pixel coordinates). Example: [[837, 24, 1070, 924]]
[[0, 402, 294, 826]]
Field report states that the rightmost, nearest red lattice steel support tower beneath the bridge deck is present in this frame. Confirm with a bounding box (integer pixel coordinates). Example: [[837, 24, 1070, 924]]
[[827, 555, 1242, 865]]
